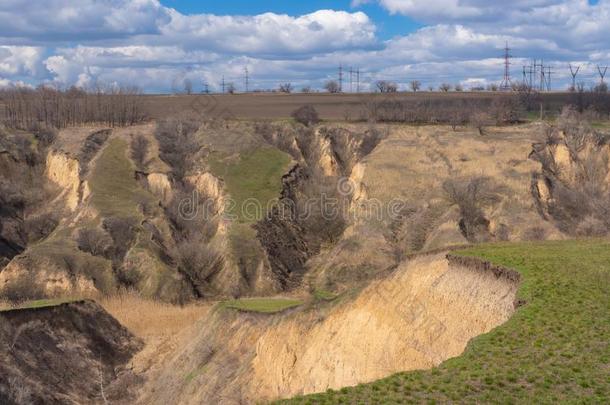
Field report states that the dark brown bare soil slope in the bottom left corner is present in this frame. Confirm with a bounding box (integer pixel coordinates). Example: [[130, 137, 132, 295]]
[[0, 301, 142, 405]]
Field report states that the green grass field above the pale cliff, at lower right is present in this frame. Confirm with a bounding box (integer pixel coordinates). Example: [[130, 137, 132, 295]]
[[279, 240, 610, 404]]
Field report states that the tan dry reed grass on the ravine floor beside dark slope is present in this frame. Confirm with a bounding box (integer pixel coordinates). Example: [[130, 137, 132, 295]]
[[99, 292, 212, 340]]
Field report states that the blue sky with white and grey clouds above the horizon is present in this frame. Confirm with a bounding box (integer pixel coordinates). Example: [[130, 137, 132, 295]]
[[0, 0, 610, 93]]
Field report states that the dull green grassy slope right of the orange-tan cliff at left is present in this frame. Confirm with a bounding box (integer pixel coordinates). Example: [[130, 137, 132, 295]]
[[89, 138, 153, 218]]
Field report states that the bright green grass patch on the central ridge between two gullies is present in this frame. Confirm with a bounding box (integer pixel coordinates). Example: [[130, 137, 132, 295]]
[[210, 147, 291, 223]]
